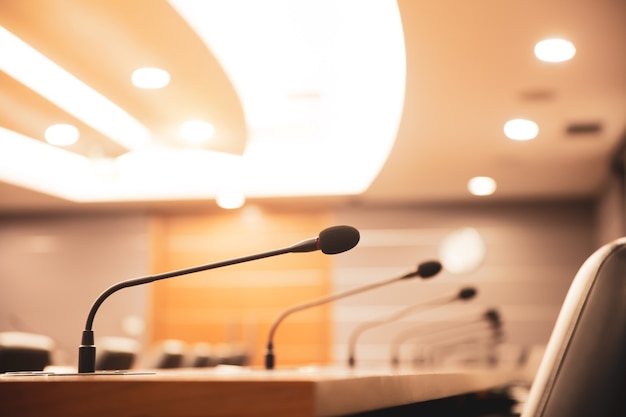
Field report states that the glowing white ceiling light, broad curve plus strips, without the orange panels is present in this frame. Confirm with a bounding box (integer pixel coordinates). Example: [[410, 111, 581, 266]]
[[0, 0, 406, 202]]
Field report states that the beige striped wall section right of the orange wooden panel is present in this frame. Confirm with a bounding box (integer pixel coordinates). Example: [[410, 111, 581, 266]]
[[334, 202, 595, 363]]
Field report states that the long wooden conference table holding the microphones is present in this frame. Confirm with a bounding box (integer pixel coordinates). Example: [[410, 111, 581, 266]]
[[0, 366, 515, 417]]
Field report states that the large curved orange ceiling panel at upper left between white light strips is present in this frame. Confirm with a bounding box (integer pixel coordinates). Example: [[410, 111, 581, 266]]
[[0, 0, 247, 156]]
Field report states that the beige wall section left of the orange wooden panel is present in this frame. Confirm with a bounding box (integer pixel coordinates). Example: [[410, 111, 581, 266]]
[[0, 214, 149, 365]]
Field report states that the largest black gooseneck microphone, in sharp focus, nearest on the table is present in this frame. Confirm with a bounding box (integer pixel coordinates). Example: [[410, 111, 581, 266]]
[[78, 226, 360, 373]]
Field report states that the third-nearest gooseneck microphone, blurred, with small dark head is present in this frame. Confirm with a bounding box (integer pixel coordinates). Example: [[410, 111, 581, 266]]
[[348, 287, 476, 368]]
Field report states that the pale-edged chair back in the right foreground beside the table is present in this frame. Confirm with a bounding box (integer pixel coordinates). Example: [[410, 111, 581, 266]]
[[522, 238, 626, 417]]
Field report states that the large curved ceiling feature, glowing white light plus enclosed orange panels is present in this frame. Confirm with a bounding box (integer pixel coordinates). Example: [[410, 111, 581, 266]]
[[0, 0, 406, 203]]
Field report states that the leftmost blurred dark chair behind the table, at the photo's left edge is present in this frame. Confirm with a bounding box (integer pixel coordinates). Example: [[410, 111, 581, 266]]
[[0, 332, 54, 372]]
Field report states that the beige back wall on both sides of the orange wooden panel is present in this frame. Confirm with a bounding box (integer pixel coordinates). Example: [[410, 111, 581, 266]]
[[0, 202, 596, 363]]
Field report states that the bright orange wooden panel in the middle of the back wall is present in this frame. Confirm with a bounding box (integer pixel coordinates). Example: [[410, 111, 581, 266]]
[[148, 208, 334, 366]]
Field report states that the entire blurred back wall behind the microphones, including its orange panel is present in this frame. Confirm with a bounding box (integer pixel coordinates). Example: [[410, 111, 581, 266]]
[[0, 192, 623, 364]]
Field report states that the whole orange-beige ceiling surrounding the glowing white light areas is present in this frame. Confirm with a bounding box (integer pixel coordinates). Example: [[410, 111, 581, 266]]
[[0, 0, 626, 213]]
